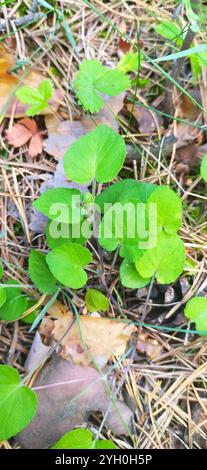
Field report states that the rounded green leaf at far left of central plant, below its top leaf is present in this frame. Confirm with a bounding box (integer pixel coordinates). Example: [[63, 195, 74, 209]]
[[33, 188, 83, 223]]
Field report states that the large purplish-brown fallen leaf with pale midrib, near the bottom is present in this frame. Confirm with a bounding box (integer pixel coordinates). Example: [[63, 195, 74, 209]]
[[16, 355, 132, 449]]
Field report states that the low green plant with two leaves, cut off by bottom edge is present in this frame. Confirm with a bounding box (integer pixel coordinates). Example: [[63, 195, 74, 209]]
[[51, 428, 117, 449]]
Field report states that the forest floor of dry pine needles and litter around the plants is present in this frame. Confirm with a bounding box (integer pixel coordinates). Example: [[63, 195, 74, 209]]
[[0, 0, 207, 449]]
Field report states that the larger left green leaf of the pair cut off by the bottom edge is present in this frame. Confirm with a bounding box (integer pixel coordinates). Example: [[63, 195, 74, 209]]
[[51, 429, 93, 449]]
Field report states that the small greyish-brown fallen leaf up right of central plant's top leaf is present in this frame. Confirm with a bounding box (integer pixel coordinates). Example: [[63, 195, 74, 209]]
[[127, 103, 160, 134]]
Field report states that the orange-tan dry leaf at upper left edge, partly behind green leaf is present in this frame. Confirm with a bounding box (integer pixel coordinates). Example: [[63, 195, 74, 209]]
[[0, 45, 62, 117]]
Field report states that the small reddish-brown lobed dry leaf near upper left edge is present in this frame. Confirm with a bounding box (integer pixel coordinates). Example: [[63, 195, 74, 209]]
[[5, 117, 43, 158]]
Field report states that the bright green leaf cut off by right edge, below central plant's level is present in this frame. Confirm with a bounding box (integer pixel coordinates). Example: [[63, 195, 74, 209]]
[[184, 297, 207, 336]]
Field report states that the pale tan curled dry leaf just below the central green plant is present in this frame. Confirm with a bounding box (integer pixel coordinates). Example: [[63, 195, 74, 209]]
[[40, 304, 136, 367]]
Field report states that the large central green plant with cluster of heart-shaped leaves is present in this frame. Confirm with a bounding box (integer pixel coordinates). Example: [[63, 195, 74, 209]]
[[29, 121, 185, 294]]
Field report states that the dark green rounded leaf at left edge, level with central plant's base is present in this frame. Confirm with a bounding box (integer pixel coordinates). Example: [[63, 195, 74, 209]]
[[0, 280, 28, 321]]
